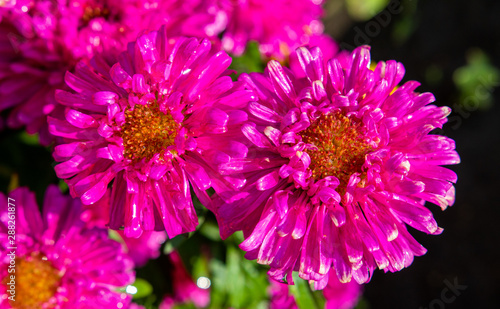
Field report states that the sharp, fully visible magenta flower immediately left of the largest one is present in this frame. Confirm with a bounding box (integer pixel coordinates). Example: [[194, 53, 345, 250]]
[[49, 28, 252, 238]]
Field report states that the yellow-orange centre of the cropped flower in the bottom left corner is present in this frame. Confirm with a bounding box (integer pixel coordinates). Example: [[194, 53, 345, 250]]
[[2, 254, 61, 309]]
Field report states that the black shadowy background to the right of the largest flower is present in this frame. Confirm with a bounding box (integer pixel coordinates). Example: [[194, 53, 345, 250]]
[[325, 0, 500, 309]]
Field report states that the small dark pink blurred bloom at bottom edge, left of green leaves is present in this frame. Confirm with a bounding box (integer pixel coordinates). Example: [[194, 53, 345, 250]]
[[160, 251, 210, 309]]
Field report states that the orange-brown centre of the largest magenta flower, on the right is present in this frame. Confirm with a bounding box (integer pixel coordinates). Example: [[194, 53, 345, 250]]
[[299, 113, 373, 191]]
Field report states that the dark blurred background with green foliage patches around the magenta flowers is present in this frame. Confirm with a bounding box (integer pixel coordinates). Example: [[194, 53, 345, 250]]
[[0, 0, 500, 309]]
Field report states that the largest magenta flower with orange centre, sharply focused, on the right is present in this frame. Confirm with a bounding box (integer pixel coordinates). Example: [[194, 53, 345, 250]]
[[214, 46, 460, 289]]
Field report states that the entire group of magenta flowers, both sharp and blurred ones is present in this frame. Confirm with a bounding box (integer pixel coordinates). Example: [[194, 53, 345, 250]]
[[0, 0, 460, 308]]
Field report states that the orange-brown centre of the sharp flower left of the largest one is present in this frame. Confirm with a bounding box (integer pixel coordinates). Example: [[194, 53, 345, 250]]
[[121, 102, 180, 162]]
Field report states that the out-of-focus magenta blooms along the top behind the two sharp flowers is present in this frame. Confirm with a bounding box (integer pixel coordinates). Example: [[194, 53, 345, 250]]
[[0, 0, 328, 145]]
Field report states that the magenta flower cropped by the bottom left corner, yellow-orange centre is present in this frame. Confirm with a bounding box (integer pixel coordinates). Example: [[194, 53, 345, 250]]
[[0, 186, 134, 309]]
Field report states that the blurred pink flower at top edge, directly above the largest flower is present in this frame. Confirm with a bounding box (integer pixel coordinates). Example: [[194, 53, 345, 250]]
[[222, 0, 323, 60]]
